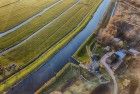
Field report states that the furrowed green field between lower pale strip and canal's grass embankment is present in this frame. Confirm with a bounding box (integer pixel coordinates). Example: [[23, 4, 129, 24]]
[[0, 0, 100, 66]]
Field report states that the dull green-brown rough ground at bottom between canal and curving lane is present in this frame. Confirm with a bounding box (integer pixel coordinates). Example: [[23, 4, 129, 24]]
[[35, 63, 109, 94]]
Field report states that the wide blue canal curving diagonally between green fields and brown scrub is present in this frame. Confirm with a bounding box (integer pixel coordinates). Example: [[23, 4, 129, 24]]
[[7, 0, 114, 94]]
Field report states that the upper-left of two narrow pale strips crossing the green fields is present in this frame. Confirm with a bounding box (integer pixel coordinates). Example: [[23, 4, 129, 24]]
[[0, 0, 63, 37]]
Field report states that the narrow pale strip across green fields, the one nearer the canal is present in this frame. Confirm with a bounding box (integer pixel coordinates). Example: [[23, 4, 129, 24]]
[[0, 0, 80, 55]]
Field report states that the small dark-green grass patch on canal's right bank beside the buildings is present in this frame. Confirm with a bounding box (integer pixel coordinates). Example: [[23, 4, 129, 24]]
[[73, 31, 103, 64]]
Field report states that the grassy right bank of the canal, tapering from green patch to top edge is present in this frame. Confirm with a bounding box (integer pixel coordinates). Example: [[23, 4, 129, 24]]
[[73, 0, 116, 64]]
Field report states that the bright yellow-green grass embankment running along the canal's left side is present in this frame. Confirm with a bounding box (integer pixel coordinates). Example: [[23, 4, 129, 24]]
[[0, 0, 102, 92]]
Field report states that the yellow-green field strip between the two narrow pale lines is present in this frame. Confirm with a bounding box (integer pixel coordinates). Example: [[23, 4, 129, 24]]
[[0, 0, 76, 51]]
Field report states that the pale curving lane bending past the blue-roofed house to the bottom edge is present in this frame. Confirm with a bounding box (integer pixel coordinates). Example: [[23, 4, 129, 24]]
[[100, 52, 118, 94]]
